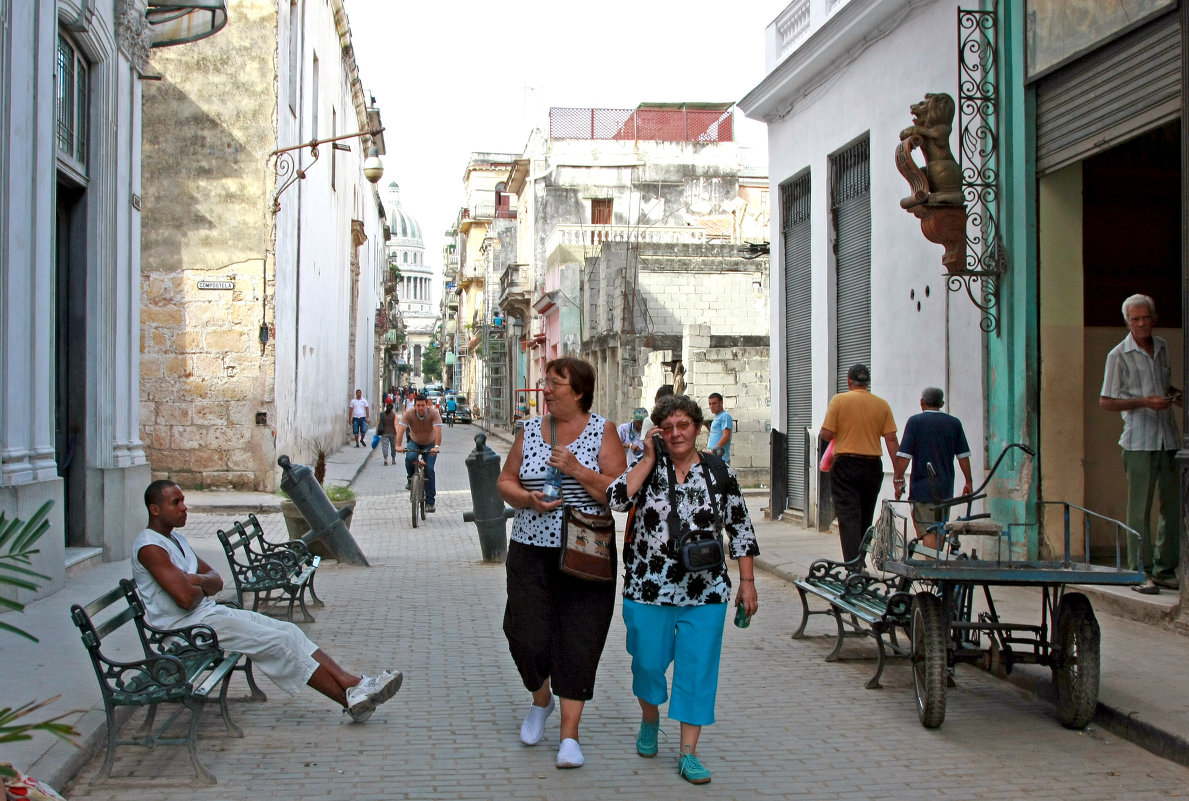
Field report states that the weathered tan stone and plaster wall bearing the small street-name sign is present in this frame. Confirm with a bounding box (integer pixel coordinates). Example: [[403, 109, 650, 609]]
[[140, 0, 277, 490]]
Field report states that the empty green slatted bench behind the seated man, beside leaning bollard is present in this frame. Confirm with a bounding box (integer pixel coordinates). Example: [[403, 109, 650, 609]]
[[216, 515, 323, 623]]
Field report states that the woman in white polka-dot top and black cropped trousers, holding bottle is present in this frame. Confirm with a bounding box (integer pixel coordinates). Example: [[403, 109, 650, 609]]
[[498, 358, 625, 768]]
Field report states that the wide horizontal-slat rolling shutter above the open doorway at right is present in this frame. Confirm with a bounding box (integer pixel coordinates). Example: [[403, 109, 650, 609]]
[[1036, 12, 1181, 175]]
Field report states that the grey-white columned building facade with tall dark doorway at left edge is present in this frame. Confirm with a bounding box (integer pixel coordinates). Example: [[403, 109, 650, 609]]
[[0, 0, 222, 600]]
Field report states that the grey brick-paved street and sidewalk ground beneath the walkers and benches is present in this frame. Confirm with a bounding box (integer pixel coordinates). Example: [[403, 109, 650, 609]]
[[0, 425, 1189, 801]]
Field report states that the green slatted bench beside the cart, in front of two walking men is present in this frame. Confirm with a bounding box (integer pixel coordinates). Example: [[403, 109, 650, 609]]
[[793, 529, 913, 689]]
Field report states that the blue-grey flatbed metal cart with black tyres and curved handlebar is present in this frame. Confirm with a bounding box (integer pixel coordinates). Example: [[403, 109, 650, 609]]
[[875, 443, 1144, 729]]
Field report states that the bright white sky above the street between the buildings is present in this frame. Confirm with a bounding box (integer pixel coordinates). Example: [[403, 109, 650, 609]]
[[344, 0, 788, 270]]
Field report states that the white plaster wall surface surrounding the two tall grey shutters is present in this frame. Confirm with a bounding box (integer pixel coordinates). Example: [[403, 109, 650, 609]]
[[768, 0, 984, 511]]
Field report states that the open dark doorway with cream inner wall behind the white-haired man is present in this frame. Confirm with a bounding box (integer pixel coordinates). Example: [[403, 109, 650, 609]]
[[1037, 120, 1184, 565]]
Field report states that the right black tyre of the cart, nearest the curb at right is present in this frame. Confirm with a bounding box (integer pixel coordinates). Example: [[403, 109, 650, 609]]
[[1052, 592, 1102, 729]]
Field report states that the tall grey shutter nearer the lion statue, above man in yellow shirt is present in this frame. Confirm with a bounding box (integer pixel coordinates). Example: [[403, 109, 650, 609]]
[[830, 140, 872, 392]]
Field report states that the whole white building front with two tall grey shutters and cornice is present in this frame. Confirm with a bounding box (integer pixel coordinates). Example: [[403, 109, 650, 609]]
[[740, 0, 983, 525]]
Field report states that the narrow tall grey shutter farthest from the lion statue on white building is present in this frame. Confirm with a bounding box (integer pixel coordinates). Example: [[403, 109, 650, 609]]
[[780, 172, 813, 511]]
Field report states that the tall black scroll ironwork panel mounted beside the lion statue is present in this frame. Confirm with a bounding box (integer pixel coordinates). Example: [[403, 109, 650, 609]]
[[946, 8, 1007, 334]]
